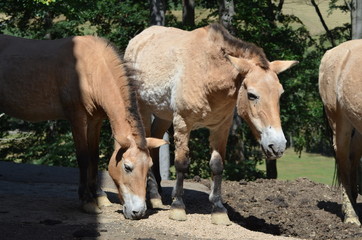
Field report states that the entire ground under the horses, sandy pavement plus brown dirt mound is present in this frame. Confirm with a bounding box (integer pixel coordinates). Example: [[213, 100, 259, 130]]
[[0, 162, 362, 240]]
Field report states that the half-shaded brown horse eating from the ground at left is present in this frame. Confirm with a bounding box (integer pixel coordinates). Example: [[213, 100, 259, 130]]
[[0, 35, 164, 219]]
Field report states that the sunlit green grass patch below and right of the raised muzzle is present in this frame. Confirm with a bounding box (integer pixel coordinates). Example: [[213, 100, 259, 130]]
[[258, 148, 334, 185]]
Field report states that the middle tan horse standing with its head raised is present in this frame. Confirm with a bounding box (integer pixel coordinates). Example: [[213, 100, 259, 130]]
[[125, 24, 297, 224]]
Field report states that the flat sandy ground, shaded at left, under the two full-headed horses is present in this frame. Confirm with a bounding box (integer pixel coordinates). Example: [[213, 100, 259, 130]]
[[0, 162, 300, 240]]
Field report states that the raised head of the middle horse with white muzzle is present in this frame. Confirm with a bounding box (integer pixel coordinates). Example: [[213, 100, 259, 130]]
[[227, 56, 298, 159]]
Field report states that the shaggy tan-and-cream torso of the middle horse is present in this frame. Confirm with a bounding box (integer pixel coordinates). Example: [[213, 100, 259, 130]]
[[125, 26, 236, 124]]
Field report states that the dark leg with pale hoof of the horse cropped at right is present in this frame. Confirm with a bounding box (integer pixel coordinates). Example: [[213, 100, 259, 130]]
[[334, 119, 361, 225]]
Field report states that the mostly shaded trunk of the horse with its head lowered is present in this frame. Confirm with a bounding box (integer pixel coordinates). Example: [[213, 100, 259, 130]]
[[0, 35, 108, 121]]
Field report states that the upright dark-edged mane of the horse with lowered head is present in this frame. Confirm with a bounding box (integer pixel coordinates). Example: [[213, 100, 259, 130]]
[[100, 40, 147, 149]]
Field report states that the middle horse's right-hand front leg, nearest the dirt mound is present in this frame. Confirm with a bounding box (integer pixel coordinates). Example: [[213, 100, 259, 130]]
[[209, 119, 231, 225]]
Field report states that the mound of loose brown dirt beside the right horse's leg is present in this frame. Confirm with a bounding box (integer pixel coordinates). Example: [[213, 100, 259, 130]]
[[216, 178, 362, 240]]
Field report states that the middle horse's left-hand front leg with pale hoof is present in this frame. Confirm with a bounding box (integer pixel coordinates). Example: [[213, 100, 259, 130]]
[[169, 116, 190, 221]]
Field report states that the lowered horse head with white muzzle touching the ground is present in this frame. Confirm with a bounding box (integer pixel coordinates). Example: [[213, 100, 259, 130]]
[[108, 137, 167, 219]]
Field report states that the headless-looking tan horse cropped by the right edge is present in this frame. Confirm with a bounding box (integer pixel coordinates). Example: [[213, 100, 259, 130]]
[[319, 40, 362, 225]]
